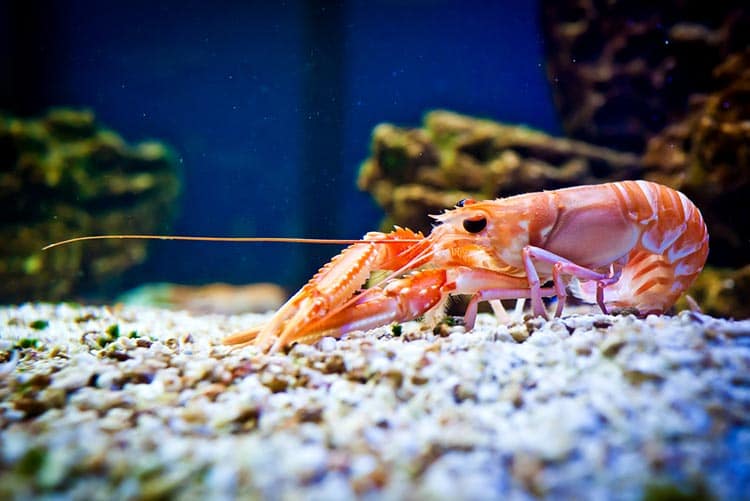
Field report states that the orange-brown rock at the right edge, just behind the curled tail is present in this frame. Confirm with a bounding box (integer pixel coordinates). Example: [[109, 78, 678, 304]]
[[643, 49, 750, 267]]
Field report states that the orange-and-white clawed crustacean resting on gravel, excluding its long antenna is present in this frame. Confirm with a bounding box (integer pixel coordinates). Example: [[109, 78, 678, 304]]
[[225, 181, 708, 350]]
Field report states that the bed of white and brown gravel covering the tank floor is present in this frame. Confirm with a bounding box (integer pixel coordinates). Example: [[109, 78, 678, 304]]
[[0, 304, 750, 501]]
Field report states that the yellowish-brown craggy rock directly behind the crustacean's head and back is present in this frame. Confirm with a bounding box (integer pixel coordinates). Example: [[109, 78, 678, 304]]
[[358, 111, 641, 231]]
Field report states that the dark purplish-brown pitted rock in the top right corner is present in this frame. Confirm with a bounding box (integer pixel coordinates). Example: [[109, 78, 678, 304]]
[[540, 0, 750, 153]]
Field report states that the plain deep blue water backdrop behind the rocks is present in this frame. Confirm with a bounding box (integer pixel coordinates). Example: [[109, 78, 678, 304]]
[[4, 0, 560, 288]]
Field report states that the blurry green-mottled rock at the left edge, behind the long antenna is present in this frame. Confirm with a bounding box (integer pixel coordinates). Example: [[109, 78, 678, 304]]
[[0, 109, 180, 302]]
